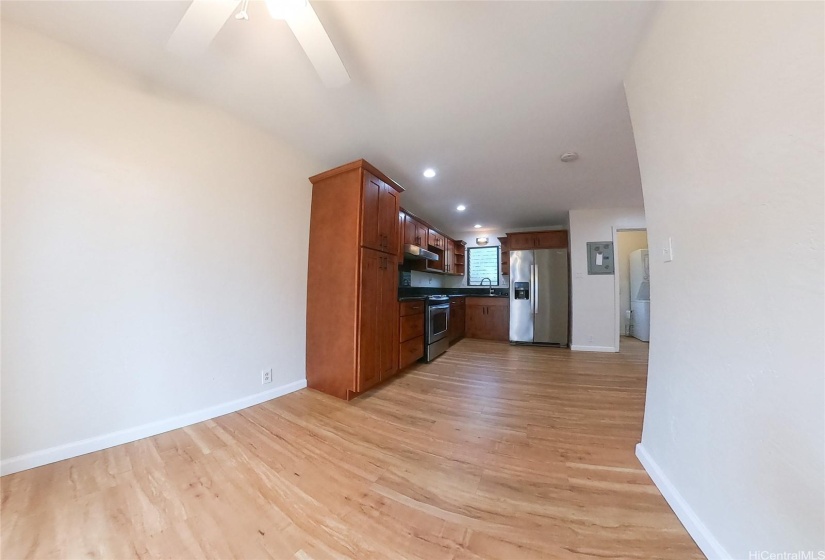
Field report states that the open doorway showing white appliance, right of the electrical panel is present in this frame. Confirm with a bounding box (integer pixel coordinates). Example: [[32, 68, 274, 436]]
[[613, 228, 650, 351]]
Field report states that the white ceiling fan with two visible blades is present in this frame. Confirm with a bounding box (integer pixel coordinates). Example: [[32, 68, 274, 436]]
[[166, 0, 350, 88]]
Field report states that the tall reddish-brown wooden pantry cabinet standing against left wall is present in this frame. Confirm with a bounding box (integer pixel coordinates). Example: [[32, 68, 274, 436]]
[[306, 160, 404, 399]]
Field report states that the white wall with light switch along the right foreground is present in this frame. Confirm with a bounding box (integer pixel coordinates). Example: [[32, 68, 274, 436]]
[[626, 2, 825, 559]]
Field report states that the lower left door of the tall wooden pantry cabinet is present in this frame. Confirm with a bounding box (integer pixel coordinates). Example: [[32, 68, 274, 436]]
[[355, 249, 385, 393]]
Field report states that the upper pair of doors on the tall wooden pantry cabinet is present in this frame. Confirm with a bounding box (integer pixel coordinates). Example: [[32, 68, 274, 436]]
[[361, 171, 398, 253]]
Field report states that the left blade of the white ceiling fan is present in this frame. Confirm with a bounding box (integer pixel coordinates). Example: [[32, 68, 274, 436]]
[[166, 0, 240, 56]]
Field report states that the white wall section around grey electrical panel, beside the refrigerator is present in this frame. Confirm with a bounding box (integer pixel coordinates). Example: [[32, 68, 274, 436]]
[[569, 208, 655, 352]]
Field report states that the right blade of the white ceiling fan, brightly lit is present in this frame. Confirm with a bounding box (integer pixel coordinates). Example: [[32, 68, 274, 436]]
[[286, 3, 350, 88]]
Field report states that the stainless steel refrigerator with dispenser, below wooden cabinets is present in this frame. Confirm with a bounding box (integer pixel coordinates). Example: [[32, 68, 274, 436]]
[[510, 249, 570, 346]]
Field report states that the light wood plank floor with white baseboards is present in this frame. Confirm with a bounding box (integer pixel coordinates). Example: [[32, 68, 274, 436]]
[[0, 339, 703, 560]]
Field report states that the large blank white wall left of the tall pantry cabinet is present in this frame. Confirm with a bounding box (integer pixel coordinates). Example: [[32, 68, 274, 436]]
[[0, 22, 322, 472]]
